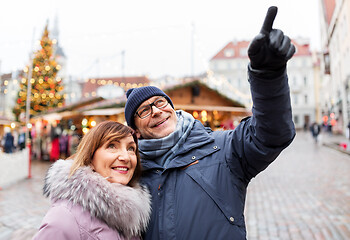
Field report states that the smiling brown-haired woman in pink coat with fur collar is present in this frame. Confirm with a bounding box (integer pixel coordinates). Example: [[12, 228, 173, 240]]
[[33, 121, 151, 240]]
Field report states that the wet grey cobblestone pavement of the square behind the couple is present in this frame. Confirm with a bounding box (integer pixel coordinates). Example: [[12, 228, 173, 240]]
[[0, 132, 350, 240]]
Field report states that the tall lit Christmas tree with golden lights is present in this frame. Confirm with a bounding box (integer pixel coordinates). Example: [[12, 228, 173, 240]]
[[13, 24, 64, 119]]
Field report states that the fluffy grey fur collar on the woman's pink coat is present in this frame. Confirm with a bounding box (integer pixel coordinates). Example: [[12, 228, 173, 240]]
[[44, 160, 151, 237]]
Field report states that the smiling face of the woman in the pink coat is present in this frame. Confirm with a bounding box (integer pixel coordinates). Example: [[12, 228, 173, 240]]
[[91, 134, 137, 185]]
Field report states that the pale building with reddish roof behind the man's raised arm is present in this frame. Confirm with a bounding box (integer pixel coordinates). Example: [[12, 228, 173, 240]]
[[207, 39, 317, 128]]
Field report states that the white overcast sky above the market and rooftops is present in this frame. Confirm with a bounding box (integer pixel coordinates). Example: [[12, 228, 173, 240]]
[[0, 0, 320, 78]]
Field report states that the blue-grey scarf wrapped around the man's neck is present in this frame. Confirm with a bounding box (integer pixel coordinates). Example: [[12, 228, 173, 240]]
[[139, 110, 195, 168]]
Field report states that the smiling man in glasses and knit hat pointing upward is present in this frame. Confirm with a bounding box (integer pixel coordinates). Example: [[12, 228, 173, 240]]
[[125, 7, 295, 240]]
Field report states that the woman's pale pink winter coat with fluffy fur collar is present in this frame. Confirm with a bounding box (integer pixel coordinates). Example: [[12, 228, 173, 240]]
[[33, 160, 151, 240]]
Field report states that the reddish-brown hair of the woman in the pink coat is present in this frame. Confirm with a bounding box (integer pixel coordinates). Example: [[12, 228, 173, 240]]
[[68, 121, 141, 186]]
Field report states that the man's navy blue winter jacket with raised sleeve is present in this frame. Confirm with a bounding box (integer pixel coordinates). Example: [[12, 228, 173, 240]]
[[142, 73, 295, 240]]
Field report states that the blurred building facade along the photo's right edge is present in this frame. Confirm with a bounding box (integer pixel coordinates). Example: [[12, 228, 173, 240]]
[[319, 0, 350, 133]]
